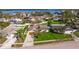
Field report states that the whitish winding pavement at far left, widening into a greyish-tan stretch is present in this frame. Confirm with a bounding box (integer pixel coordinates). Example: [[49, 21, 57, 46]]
[[1, 24, 28, 48]]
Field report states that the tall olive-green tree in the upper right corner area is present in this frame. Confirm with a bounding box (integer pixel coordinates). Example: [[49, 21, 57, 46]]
[[62, 10, 76, 28]]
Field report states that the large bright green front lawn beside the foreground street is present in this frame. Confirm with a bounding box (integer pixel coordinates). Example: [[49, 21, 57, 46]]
[[35, 32, 72, 41]]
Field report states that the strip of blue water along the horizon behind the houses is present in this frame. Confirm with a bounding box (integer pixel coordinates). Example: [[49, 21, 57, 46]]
[[0, 9, 61, 13]]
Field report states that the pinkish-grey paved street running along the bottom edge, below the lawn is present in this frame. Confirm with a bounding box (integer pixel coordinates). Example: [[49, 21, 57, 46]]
[[25, 41, 79, 49]]
